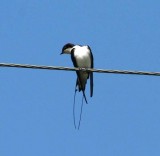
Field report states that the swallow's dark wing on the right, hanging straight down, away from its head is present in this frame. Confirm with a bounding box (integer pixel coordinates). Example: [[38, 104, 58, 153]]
[[88, 46, 94, 97]]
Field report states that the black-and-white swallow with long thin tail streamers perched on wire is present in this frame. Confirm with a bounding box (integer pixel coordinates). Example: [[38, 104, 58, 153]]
[[61, 43, 94, 129]]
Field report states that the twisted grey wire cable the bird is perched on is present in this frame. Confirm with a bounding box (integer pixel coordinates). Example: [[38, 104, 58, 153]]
[[0, 63, 160, 76]]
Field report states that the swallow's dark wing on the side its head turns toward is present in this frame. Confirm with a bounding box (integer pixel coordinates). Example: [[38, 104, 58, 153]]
[[71, 48, 88, 103]]
